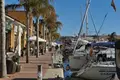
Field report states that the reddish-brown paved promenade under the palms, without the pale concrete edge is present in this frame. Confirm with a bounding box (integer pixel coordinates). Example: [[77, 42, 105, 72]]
[[0, 52, 52, 80]]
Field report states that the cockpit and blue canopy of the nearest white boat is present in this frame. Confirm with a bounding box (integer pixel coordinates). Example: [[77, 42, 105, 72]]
[[91, 42, 115, 62]]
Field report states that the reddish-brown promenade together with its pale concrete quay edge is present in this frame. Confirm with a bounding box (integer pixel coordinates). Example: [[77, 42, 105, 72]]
[[0, 52, 64, 80]]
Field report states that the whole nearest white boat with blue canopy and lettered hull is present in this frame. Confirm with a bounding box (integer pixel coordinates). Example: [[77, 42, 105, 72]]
[[76, 42, 116, 80]]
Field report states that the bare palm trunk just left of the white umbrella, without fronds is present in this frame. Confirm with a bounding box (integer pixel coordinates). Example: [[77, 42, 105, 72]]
[[26, 11, 30, 63]]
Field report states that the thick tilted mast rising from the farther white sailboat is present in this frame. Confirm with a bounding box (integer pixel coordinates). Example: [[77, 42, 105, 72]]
[[73, 0, 91, 53]]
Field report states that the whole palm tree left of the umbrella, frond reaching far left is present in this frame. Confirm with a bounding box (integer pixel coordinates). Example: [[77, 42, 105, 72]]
[[6, 0, 39, 63]]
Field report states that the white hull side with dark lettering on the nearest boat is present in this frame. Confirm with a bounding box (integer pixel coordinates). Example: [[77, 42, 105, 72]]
[[79, 66, 116, 80]]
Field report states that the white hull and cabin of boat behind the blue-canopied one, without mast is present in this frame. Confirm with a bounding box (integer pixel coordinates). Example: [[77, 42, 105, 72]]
[[69, 39, 89, 71]]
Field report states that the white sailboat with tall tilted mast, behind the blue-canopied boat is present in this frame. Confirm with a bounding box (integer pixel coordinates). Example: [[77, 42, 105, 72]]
[[69, 0, 91, 71]]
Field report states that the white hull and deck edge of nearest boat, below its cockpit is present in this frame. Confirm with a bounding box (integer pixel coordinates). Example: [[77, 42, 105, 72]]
[[77, 62, 116, 80]]
